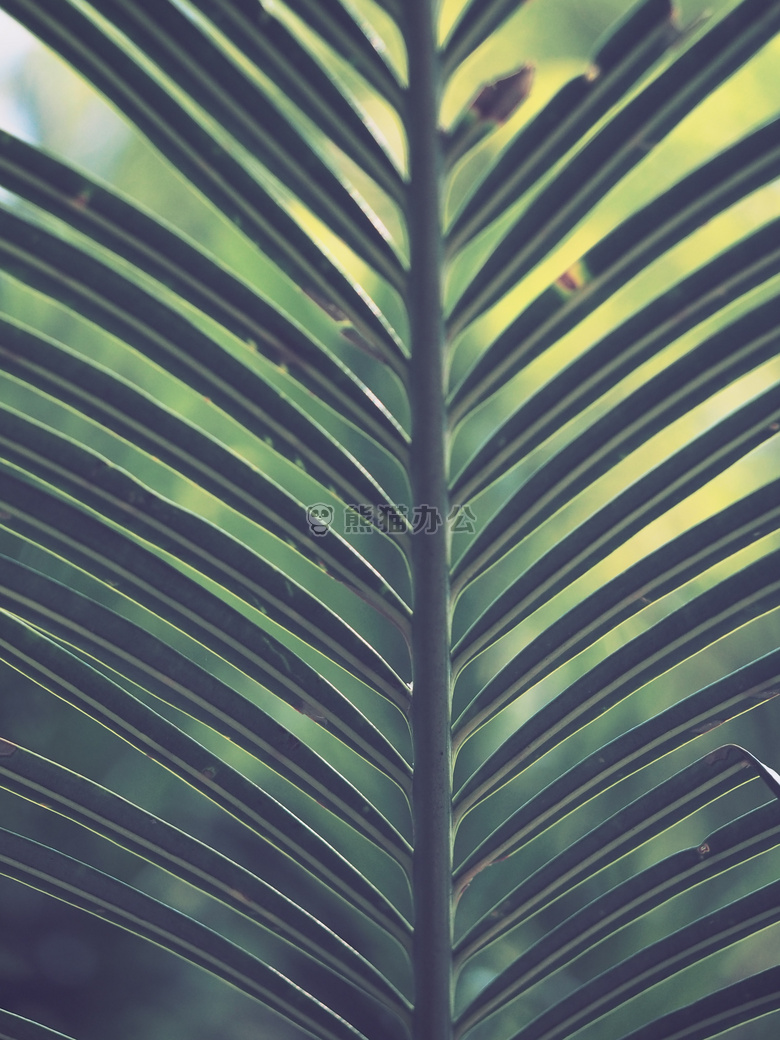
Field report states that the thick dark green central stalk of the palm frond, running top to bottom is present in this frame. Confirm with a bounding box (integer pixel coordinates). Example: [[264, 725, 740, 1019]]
[[407, 0, 452, 1040]]
